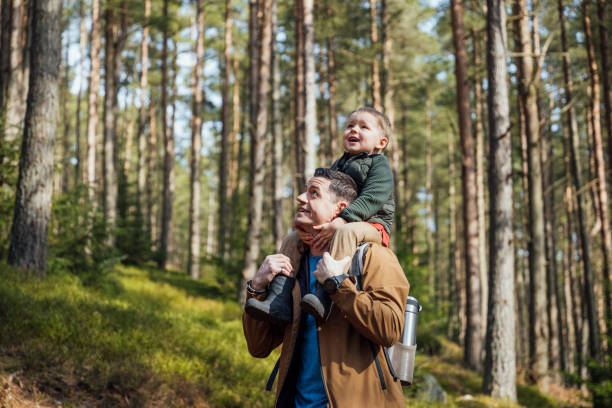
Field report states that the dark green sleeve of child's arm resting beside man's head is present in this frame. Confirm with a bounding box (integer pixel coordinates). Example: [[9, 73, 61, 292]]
[[339, 155, 393, 222]]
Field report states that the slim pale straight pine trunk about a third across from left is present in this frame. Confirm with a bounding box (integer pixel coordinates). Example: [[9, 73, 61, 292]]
[[187, 0, 204, 279]]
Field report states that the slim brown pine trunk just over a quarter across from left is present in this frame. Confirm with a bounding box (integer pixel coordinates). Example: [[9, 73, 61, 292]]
[[158, 0, 174, 269]]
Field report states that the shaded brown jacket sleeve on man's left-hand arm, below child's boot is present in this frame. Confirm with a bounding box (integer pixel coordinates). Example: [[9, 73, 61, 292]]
[[242, 292, 283, 358]]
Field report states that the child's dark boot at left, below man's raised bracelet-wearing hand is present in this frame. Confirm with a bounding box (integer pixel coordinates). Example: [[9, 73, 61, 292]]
[[244, 274, 295, 324]]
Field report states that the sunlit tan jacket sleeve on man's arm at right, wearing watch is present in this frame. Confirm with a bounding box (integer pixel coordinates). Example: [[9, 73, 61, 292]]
[[331, 245, 410, 347]]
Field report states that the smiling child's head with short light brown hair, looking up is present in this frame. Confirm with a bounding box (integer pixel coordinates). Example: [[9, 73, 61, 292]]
[[342, 111, 389, 154]]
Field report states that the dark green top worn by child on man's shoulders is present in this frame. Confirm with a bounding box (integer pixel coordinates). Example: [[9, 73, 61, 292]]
[[331, 152, 395, 234]]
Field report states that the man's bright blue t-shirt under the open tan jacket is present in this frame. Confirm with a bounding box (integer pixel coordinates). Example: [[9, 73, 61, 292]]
[[295, 254, 328, 408]]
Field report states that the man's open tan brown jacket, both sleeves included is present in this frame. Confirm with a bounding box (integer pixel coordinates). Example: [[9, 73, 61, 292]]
[[242, 245, 410, 408]]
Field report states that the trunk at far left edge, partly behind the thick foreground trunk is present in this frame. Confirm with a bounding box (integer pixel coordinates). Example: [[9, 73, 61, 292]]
[[4, 0, 33, 143]]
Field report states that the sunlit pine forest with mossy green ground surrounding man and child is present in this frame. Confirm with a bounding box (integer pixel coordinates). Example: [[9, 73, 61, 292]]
[[0, 0, 612, 408]]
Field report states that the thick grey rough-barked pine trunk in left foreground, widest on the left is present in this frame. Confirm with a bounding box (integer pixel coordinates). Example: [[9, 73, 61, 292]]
[[8, 0, 62, 277]]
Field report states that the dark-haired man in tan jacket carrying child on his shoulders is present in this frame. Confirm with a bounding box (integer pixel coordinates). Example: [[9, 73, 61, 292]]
[[243, 169, 409, 407]]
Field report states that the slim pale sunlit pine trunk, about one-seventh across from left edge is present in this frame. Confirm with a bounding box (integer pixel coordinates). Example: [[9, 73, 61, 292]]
[[87, 0, 100, 210]]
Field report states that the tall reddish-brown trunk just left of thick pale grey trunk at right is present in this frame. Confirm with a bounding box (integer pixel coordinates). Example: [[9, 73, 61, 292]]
[[451, 0, 483, 370]]
